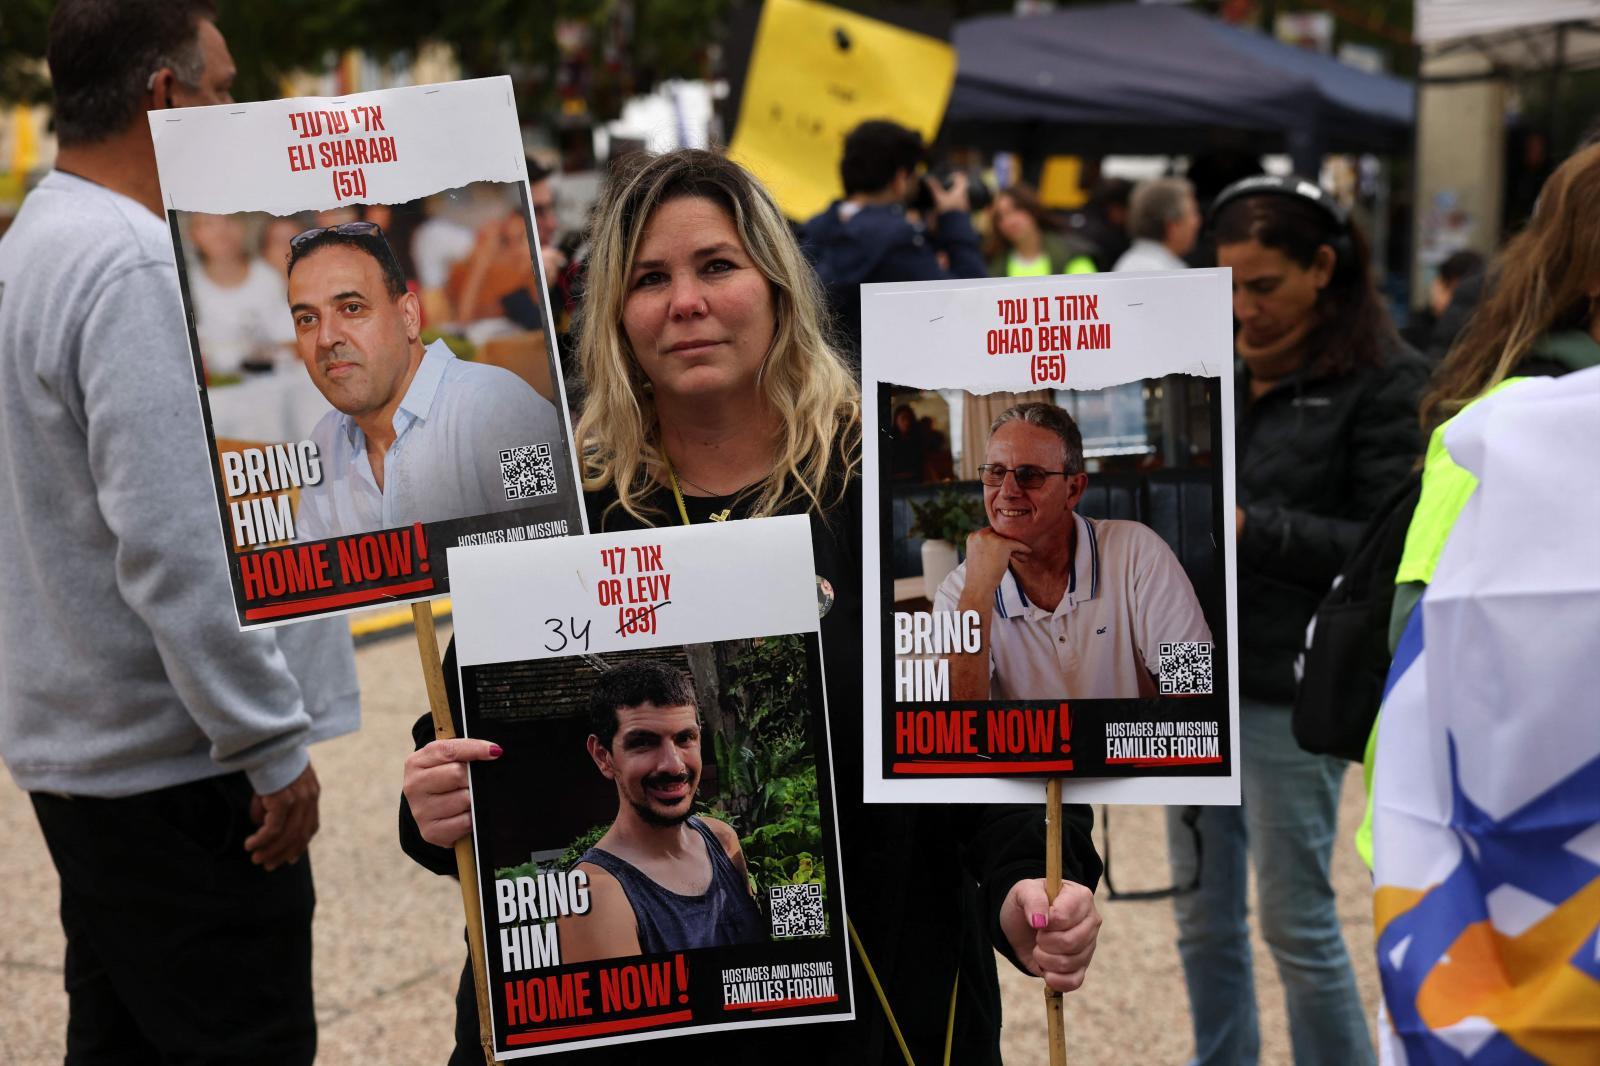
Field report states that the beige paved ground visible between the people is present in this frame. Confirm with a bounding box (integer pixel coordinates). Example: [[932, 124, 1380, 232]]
[[0, 637, 1378, 1066]]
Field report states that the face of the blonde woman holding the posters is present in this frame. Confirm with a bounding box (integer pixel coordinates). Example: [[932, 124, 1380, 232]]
[[622, 197, 778, 399]]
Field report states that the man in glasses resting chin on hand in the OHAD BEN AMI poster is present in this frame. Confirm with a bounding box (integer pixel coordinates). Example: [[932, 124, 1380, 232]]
[[933, 402, 1211, 699]]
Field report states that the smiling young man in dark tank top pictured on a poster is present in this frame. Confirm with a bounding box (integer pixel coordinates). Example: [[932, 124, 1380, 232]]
[[558, 659, 766, 964]]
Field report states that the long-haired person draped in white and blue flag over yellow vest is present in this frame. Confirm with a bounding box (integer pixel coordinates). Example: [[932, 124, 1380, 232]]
[[1357, 146, 1600, 1063]]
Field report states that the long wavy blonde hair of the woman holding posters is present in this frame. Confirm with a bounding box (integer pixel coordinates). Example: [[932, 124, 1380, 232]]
[[576, 149, 861, 523]]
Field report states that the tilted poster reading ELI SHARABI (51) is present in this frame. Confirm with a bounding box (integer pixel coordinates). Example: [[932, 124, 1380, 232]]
[[150, 77, 584, 629]]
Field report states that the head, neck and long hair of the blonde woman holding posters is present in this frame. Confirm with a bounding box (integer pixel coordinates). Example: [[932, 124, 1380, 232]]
[[578, 152, 861, 531]]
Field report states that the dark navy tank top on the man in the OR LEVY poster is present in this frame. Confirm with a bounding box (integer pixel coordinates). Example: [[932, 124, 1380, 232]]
[[579, 818, 766, 956]]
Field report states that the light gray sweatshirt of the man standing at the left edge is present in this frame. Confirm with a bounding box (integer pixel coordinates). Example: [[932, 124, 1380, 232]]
[[0, 171, 358, 795]]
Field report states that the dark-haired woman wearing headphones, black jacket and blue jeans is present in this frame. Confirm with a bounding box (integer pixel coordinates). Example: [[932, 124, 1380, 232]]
[[1168, 178, 1427, 1066]]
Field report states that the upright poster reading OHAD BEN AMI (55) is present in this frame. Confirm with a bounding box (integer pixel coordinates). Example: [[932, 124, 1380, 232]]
[[862, 271, 1238, 804]]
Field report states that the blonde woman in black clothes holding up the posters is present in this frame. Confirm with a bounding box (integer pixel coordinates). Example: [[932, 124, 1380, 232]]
[[400, 150, 1101, 1066]]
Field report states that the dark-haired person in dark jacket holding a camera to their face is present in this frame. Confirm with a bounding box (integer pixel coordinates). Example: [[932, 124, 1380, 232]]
[[800, 118, 989, 360]]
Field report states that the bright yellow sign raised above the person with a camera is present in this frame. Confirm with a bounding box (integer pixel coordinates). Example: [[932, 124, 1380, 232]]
[[728, 0, 955, 219]]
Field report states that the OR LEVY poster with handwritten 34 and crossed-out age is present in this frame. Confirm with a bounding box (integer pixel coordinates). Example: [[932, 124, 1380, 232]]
[[450, 517, 853, 1058]]
